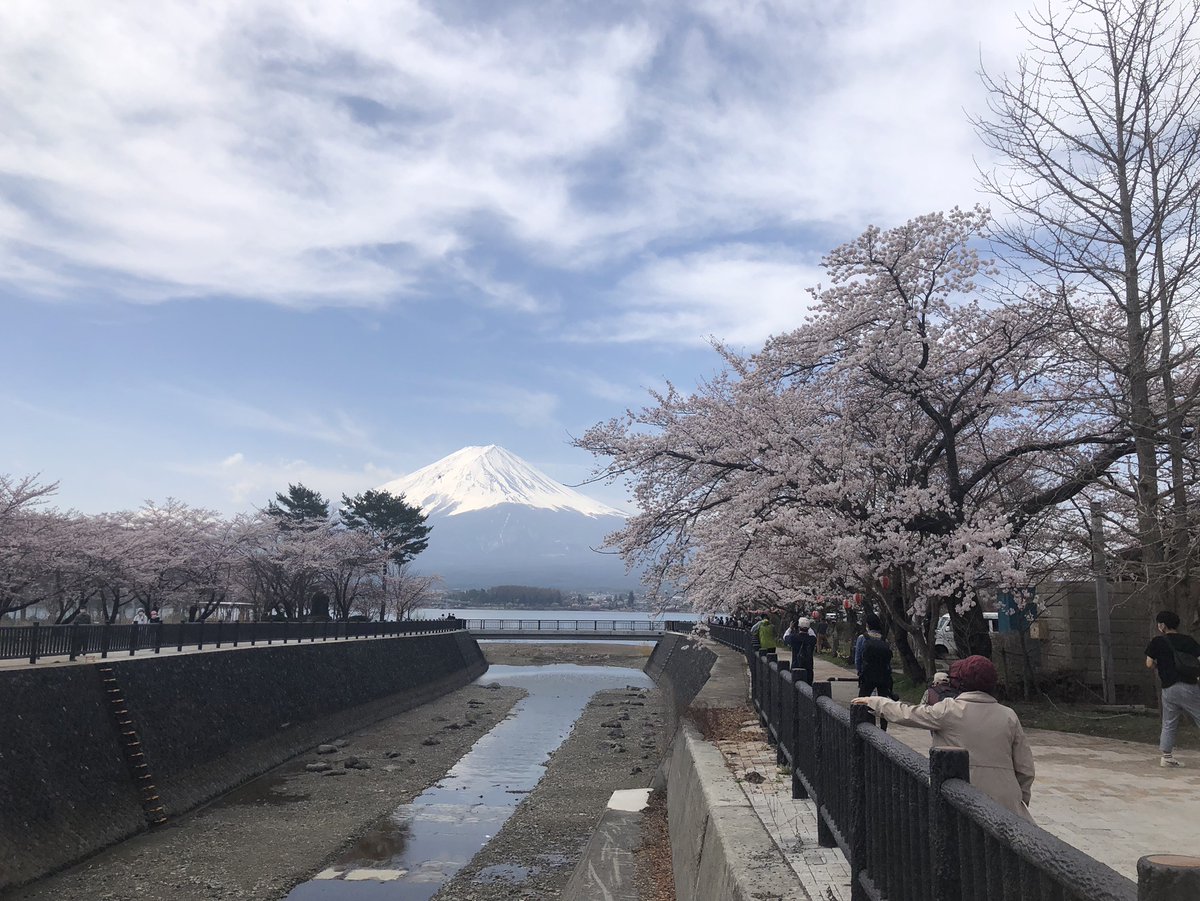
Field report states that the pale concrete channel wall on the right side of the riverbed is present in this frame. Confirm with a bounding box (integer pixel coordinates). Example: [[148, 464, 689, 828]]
[[646, 633, 809, 901]]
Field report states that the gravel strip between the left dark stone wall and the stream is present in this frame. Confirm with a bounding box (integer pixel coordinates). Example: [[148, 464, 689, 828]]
[[2, 677, 524, 901]]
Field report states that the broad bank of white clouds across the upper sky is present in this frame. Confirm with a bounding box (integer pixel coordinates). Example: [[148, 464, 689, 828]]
[[0, 0, 1019, 341]]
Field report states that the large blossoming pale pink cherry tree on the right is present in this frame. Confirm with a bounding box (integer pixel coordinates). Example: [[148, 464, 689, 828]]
[[577, 210, 1132, 676]]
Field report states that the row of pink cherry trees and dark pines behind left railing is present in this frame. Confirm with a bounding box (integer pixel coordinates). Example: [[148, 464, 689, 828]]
[[0, 475, 437, 623]]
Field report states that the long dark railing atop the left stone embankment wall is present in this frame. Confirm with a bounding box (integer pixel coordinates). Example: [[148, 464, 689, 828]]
[[0, 619, 463, 663]]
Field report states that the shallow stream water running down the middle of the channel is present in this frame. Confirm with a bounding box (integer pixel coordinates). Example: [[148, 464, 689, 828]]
[[287, 663, 653, 901]]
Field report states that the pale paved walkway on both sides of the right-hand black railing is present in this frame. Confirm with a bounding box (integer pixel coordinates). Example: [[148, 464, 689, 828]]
[[716, 651, 1200, 901]]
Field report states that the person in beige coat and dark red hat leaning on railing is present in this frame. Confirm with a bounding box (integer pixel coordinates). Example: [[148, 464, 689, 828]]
[[851, 655, 1033, 822]]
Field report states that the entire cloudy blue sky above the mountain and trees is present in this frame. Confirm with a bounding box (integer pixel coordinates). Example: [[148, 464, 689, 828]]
[[0, 0, 1025, 513]]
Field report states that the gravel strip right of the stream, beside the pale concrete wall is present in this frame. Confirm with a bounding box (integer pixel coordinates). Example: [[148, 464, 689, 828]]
[[433, 681, 665, 901]]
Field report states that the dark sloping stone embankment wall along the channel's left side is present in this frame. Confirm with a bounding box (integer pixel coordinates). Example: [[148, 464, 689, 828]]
[[0, 632, 487, 891]]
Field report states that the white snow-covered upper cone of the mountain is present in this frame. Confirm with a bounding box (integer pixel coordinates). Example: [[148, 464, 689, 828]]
[[379, 444, 625, 516]]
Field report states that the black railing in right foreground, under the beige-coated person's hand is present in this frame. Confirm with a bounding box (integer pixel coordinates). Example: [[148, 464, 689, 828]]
[[739, 647, 1171, 901]]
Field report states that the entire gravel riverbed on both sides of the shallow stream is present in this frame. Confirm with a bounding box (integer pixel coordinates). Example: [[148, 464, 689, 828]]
[[0, 642, 670, 901]]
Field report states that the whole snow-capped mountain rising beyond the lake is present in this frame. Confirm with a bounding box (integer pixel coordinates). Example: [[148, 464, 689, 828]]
[[379, 444, 638, 591]]
